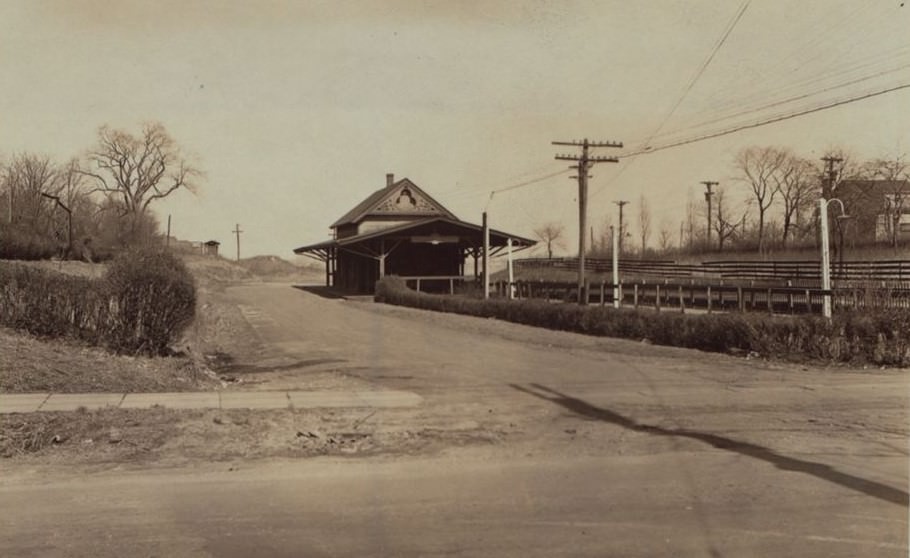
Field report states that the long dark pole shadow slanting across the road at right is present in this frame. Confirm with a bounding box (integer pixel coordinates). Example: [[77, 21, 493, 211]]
[[509, 384, 910, 507]]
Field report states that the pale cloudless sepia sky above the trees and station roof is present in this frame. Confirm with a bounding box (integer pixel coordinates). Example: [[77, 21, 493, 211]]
[[0, 0, 910, 257]]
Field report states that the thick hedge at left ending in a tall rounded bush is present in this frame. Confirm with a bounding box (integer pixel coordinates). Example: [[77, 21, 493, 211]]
[[0, 251, 196, 355]]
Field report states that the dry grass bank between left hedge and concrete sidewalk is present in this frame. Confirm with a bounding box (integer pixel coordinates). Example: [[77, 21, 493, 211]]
[[0, 328, 215, 393]]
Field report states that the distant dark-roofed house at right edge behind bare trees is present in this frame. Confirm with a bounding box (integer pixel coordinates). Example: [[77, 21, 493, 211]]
[[834, 180, 910, 245]]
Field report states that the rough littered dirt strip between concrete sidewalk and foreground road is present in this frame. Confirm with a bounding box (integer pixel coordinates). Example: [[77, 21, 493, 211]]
[[0, 407, 507, 465]]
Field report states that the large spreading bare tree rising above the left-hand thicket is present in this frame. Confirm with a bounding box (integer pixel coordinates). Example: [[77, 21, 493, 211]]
[[79, 123, 202, 241]]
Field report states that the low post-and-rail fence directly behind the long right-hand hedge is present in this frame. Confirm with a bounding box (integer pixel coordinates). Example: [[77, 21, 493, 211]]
[[494, 281, 910, 314]]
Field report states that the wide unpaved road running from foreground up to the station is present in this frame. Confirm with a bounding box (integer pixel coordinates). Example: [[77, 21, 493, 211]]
[[0, 284, 910, 557]]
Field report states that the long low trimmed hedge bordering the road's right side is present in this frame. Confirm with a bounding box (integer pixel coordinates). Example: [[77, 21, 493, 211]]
[[376, 277, 910, 366]]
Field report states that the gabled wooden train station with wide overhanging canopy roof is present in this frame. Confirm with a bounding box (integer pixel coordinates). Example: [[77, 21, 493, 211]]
[[294, 174, 535, 294]]
